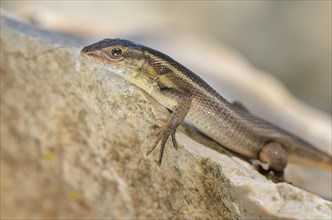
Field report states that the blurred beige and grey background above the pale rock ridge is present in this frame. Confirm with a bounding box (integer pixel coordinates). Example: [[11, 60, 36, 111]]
[[1, 1, 332, 114]]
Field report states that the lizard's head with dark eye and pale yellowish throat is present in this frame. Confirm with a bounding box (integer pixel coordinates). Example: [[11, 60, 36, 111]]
[[81, 38, 145, 75]]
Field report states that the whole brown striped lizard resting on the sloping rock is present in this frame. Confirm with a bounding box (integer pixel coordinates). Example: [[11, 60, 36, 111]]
[[80, 38, 332, 177]]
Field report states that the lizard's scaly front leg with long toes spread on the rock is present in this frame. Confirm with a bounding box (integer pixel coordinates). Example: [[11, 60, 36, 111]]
[[146, 88, 192, 166]]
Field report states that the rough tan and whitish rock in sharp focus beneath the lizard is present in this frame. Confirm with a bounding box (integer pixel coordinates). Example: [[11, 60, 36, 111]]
[[1, 12, 332, 219]]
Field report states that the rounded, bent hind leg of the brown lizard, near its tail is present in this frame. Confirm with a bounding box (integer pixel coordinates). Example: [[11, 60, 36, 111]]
[[258, 141, 287, 171]]
